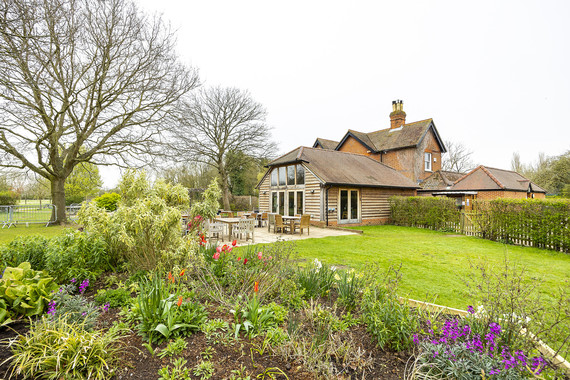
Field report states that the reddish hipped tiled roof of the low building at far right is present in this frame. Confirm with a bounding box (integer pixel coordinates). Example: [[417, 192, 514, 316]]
[[451, 165, 546, 193]]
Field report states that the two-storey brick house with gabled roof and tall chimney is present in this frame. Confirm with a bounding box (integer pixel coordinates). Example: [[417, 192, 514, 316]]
[[313, 100, 447, 183]]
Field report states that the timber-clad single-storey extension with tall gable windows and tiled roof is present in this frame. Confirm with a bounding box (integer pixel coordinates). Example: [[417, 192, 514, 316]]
[[257, 147, 418, 226]]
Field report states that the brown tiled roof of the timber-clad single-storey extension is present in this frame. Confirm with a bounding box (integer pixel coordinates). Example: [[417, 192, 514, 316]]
[[268, 147, 417, 188]]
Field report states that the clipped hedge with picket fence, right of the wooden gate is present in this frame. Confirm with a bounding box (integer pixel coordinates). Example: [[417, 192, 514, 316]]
[[473, 199, 570, 252]]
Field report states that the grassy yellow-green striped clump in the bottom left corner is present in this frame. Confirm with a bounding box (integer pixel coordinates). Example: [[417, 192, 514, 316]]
[[11, 317, 122, 380]]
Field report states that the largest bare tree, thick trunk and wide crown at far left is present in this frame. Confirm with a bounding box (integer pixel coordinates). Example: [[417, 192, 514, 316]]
[[0, 0, 198, 222]]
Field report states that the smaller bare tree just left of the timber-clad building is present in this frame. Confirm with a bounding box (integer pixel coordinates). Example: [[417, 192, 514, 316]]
[[174, 87, 275, 209]]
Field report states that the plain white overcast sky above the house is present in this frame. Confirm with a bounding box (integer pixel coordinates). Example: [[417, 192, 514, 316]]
[[102, 0, 570, 185]]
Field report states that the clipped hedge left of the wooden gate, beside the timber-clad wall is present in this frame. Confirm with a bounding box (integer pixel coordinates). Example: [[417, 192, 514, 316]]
[[390, 197, 461, 230]]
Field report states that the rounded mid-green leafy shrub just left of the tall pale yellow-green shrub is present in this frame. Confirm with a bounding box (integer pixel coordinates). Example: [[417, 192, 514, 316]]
[[45, 230, 110, 283]]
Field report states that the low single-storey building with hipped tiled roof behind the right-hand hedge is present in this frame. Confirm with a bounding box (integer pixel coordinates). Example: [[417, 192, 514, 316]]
[[426, 165, 546, 211]]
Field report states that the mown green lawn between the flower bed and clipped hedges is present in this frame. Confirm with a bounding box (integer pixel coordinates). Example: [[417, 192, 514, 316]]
[[290, 225, 570, 309]]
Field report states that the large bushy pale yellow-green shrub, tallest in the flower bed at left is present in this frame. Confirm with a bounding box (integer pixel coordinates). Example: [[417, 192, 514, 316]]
[[78, 171, 193, 270]]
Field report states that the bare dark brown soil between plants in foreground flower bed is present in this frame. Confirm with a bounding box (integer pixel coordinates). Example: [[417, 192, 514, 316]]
[[0, 281, 410, 380]]
